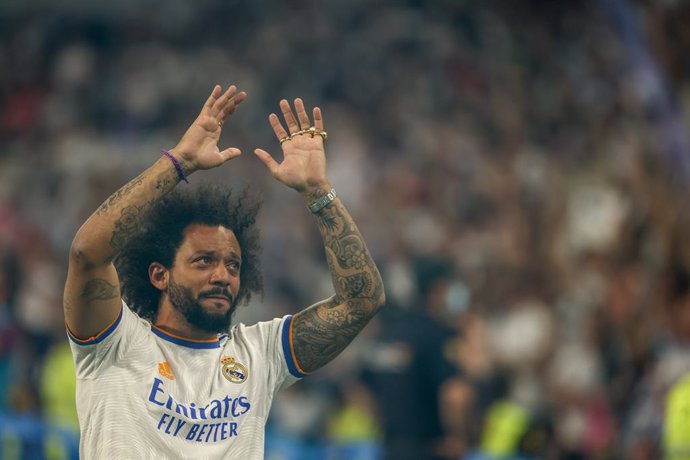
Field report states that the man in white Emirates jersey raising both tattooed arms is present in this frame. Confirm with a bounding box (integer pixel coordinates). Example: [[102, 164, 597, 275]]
[[64, 86, 384, 459]]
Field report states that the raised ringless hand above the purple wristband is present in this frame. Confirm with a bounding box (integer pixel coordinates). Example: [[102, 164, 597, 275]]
[[170, 85, 247, 172]]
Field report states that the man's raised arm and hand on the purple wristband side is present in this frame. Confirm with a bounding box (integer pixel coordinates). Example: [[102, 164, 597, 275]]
[[63, 86, 246, 338]]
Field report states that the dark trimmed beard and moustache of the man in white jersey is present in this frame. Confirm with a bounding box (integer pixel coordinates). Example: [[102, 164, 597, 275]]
[[168, 277, 237, 333]]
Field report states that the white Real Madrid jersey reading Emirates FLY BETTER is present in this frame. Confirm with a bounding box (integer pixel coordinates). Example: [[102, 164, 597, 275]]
[[68, 302, 303, 460]]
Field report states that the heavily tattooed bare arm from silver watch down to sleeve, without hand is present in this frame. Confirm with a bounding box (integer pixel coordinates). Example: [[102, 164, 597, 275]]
[[293, 201, 383, 372]]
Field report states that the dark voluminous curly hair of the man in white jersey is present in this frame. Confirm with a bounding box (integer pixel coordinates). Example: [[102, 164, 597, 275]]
[[114, 184, 263, 321]]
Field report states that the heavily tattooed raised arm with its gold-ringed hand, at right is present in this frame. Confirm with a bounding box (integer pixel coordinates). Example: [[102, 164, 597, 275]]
[[255, 99, 385, 373]]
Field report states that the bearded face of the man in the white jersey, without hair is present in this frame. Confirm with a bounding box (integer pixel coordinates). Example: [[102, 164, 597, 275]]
[[167, 224, 242, 333]]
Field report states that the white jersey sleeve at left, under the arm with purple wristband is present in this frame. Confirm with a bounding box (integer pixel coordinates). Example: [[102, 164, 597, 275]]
[[67, 301, 148, 378]]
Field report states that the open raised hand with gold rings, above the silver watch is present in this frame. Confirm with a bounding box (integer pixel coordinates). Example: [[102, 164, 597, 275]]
[[254, 98, 330, 193]]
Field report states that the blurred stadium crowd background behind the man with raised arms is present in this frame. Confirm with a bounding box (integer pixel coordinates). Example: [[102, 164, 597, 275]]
[[0, 0, 690, 460]]
